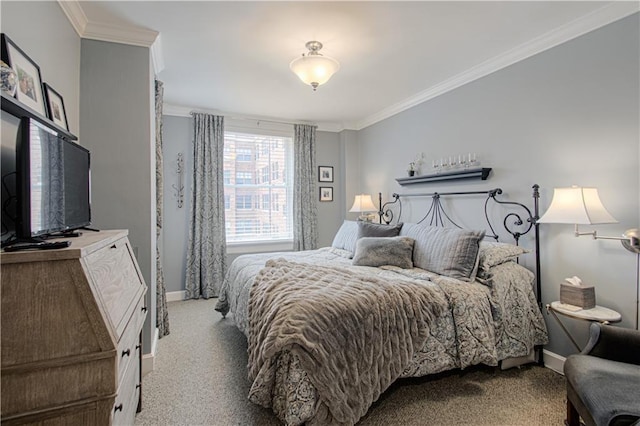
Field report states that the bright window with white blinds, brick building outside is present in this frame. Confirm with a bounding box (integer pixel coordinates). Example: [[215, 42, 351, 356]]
[[224, 131, 293, 243]]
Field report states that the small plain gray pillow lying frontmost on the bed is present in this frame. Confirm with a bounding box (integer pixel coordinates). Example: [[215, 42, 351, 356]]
[[353, 237, 413, 269]]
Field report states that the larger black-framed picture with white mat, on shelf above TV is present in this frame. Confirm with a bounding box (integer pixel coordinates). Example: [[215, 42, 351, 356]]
[[0, 34, 47, 117]]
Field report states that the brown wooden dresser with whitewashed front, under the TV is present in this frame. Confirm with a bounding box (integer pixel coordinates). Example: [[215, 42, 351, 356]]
[[0, 231, 147, 426]]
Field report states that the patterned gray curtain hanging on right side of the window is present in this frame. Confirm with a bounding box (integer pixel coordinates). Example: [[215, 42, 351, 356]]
[[293, 124, 319, 250]]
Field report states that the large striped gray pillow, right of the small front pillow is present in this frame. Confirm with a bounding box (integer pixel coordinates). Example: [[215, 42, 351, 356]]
[[400, 223, 484, 281]]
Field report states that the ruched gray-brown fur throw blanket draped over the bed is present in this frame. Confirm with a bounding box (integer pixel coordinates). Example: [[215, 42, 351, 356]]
[[248, 259, 447, 425]]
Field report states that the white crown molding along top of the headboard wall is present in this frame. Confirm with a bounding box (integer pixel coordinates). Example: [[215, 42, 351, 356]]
[[352, 1, 640, 130]]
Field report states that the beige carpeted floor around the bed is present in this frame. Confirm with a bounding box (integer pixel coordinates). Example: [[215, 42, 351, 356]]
[[135, 299, 565, 426]]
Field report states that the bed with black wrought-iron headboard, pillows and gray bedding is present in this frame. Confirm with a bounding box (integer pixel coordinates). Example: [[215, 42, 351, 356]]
[[216, 187, 548, 425]]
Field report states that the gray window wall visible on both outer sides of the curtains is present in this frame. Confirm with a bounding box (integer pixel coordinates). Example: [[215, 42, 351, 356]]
[[161, 115, 345, 292]]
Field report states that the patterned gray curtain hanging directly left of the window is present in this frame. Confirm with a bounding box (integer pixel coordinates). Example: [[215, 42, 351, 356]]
[[186, 113, 227, 299]]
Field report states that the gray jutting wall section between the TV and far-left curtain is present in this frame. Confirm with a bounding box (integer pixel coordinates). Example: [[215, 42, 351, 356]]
[[80, 40, 156, 353]]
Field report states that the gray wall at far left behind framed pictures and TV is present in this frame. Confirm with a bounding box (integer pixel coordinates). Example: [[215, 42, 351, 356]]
[[0, 1, 82, 236]]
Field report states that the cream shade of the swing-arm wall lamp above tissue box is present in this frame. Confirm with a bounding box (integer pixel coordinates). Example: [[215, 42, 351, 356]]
[[538, 186, 618, 225]]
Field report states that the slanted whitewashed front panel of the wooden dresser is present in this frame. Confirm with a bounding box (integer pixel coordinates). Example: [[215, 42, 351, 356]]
[[86, 238, 144, 341]]
